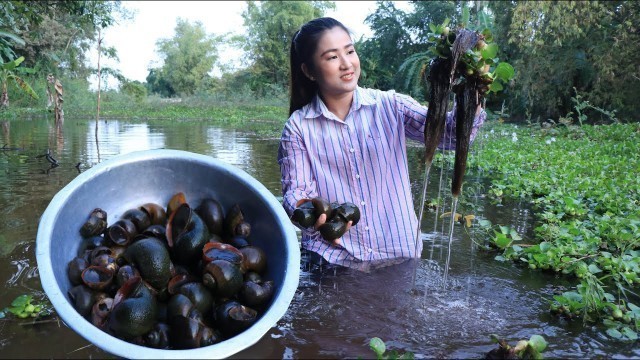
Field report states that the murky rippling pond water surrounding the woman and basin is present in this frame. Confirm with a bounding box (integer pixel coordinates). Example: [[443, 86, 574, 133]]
[[0, 118, 640, 359]]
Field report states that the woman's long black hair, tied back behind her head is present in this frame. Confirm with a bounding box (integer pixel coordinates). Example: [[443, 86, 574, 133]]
[[289, 17, 350, 116]]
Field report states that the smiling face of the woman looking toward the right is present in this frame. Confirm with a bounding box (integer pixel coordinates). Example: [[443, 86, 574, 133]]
[[303, 26, 360, 97]]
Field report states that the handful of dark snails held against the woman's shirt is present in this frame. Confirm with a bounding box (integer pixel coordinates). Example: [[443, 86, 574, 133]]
[[291, 197, 360, 241]]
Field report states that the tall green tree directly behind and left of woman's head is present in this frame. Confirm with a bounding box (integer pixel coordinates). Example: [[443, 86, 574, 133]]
[[242, 1, 335, 95]]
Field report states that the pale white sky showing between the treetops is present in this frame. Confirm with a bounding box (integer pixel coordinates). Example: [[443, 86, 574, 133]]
[[90, 1, 412, 87]]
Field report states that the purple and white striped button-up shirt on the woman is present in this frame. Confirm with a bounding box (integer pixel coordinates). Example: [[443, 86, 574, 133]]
[[278, 87, 486, 266]]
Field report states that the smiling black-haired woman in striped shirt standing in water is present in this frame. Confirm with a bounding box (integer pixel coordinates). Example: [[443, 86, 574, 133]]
[[278, 17, 486, 268]]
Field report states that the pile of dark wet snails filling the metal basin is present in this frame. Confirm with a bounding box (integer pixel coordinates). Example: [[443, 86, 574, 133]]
[[68, 193, 274, 349]]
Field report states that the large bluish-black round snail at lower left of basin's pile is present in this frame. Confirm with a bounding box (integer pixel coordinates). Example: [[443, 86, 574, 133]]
[[108, 277, 157, 339]]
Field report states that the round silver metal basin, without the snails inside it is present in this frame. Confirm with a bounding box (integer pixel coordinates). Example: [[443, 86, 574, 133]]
[[36, 150, 300, 359]]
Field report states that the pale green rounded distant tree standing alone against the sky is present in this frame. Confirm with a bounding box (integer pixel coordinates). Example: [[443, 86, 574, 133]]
[[147, 18, 223, 96]]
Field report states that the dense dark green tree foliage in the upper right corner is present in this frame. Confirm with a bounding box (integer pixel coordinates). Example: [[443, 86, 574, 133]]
[[489, 1, 640, 119]]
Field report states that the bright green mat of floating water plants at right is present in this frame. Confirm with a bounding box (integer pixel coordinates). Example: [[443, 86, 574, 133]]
[[471, 124, 640, 339]]
